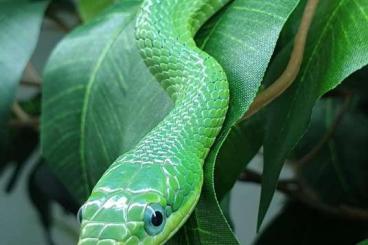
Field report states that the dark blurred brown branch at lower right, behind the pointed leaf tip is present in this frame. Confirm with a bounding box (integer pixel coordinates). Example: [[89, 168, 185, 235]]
[[238, 170, 368, 221]]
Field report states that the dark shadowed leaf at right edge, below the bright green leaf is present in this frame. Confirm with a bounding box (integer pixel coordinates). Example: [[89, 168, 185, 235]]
[[294, 98, 368, 208]]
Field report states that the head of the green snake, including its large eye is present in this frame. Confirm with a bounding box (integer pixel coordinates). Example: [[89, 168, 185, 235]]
[[78, 160, 198, 245]]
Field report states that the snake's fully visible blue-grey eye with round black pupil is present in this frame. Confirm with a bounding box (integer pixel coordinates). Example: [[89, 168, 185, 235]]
[[144, 203, 166, 236]]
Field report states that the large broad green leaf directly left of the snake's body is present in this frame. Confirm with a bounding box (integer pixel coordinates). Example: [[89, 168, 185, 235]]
[[41, 1, 172, 201]]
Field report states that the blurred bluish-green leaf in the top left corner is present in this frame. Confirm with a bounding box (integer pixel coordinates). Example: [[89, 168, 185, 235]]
[[0, 0, 47, 155]]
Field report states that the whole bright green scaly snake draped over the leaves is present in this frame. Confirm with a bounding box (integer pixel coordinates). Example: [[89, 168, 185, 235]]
[[78, 0, 229, 245]]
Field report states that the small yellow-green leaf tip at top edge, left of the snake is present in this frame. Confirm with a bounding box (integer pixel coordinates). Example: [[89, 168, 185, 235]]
[[78, 0, 118, 21]]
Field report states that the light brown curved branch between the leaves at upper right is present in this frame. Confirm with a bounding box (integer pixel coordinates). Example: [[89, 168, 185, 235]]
[[241, 0, 319, 120]]
